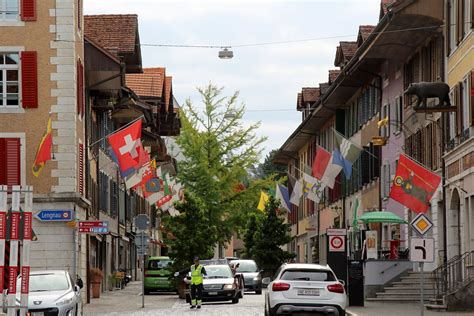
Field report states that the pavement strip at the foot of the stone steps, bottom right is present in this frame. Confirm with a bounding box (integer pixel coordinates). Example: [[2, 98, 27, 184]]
[[347, 302, 472, 316]]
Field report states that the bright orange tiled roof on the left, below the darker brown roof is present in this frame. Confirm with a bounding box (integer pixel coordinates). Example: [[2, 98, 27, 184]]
[[125, 68, 165, 98]]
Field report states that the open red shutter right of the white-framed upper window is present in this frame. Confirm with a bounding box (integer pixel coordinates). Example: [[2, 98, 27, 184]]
[[21, 52, 38, 108]]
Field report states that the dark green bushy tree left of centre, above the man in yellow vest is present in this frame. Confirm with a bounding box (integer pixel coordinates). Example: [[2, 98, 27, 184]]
[[162, 192, 216, 271]]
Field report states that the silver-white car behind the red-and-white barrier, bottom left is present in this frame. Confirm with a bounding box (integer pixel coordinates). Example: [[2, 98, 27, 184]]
[[16, 270, 83, 316]]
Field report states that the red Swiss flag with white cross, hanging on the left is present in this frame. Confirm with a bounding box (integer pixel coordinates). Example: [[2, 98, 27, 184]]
[[107, 120, 143, 171]]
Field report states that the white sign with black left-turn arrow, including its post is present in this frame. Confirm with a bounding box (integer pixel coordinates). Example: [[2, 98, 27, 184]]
[[410, 237, 434, 316]]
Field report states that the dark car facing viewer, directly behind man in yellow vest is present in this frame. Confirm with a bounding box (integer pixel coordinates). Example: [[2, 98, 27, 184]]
[[185, 264, 244, 304]]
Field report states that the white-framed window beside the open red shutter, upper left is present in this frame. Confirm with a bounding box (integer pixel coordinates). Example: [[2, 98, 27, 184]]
[[0, 53, 20, 108]]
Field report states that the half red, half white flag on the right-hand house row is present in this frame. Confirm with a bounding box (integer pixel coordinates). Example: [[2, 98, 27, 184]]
[[312, 146, 342, 189]]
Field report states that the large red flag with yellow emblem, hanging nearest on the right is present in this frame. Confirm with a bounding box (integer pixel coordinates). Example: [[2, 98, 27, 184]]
[[390, 154, 441, 213]]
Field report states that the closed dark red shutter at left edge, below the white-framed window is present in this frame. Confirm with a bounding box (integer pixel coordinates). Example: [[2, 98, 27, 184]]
[[0, 138, 20, 186]]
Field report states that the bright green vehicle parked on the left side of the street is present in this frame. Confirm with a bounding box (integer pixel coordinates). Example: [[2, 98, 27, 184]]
[[145, 257, 176, 294]]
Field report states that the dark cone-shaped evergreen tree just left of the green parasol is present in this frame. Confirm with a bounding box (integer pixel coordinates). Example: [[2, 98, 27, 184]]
[[252, 196, 294, 275]]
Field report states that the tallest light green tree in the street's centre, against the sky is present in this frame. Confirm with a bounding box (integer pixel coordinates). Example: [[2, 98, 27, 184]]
[[177, 84, 268, 245]]
